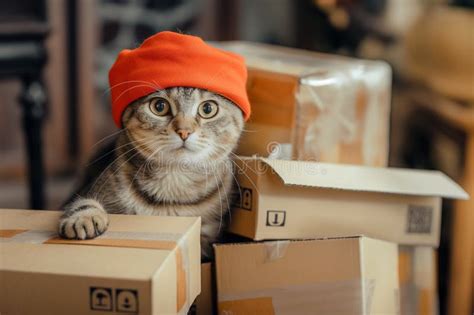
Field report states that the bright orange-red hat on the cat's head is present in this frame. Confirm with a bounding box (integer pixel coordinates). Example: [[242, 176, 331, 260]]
[[109, 32, 250, 127]]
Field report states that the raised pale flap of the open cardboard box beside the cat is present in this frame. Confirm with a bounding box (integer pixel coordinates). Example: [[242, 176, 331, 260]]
[[258, 158, 469, 199]]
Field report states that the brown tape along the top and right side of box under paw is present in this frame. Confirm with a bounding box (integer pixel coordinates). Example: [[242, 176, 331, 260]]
[[0, 229, 191, 314]]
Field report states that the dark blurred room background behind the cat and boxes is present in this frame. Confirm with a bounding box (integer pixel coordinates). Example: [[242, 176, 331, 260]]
[[0, 0, 474, 314]]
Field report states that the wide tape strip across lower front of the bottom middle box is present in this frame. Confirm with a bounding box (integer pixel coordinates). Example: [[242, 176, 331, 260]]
[[218, 279, 375, 315]]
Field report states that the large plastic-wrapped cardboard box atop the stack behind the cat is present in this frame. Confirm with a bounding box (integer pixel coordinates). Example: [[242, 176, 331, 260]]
[[218, 42, 391, 166]]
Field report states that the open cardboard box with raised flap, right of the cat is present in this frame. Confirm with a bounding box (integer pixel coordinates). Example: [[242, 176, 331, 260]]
[[228, 157, 468, 246]]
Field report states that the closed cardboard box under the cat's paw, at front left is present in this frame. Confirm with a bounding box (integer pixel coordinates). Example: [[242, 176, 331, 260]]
[[0, 210, 201, 315]]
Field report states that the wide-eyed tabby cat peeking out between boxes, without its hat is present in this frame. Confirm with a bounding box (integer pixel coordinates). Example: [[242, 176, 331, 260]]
[[59, 87, 244, 258]]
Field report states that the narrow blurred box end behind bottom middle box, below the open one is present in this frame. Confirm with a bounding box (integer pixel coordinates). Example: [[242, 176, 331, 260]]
[[398, 246, 439, 315]]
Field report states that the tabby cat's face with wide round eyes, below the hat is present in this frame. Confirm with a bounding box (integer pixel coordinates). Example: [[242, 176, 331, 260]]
[[122, 87, 244, 164]]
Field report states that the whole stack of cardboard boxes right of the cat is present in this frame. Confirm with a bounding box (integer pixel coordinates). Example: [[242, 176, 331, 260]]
[[200, 43, 467, 315]]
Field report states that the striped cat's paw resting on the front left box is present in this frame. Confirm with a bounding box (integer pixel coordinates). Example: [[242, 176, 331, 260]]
[[59, 199, 109, 240]]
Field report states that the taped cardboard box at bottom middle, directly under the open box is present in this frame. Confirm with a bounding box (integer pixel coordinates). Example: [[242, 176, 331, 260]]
[[214, 237, 399, 315]]
